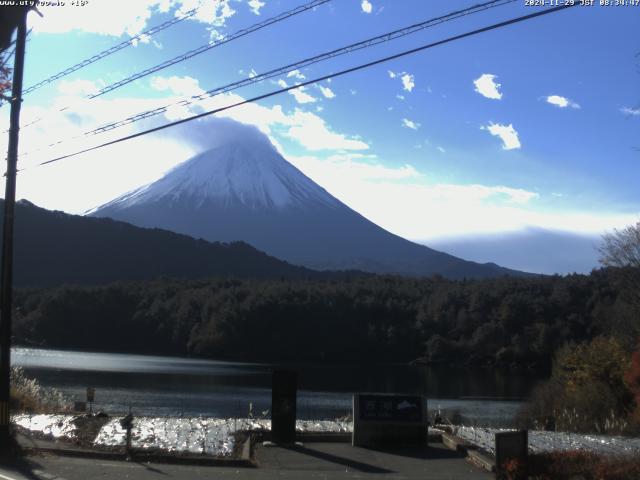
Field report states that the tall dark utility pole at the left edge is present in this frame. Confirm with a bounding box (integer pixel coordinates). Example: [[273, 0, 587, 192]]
[[0, 8, 29, 455]]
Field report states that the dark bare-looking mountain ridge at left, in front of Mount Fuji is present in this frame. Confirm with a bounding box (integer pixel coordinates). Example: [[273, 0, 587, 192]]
[[0, 199, 318, 287]]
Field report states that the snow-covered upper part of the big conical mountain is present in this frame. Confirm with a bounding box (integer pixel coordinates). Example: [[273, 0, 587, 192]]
[[95, 139, 339, 210]]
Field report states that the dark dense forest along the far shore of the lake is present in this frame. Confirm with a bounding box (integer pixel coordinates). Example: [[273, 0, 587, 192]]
[[14, 268, 640, 369]]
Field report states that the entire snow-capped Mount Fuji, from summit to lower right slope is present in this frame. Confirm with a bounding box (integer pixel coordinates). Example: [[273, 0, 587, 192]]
[[88, 125, 523, 278]]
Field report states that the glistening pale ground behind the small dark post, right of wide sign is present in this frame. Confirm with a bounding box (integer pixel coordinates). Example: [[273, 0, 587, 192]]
[[454, 427, 640, 455]]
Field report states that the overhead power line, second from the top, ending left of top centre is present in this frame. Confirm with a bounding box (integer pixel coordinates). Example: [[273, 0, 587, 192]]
[[22, 0, 331, 128]]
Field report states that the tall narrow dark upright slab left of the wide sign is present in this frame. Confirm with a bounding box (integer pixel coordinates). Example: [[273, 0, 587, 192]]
[[271, 370, 298, 443]]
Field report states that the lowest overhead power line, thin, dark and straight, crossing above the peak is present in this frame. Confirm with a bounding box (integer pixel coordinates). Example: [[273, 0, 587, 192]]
[[38, 3, 579, 165]]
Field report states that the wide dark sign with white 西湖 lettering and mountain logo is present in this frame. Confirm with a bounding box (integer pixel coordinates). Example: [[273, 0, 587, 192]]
[[352, 393, 427, 447]]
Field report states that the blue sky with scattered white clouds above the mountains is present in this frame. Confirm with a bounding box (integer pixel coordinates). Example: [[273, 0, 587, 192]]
[[0, 0, 640, 270]]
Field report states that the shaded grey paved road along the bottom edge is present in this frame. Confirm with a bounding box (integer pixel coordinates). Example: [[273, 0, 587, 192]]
[[0, 443, 494, 480]]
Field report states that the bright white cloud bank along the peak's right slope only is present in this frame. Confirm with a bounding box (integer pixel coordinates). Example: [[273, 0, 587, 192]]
[[287, 155, 637, 240]]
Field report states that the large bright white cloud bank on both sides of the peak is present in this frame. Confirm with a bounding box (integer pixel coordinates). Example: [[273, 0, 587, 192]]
[[7, 76, 637, 248]]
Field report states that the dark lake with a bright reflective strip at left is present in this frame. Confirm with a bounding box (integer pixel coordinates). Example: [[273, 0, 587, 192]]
[[12, 348, 540, 426]]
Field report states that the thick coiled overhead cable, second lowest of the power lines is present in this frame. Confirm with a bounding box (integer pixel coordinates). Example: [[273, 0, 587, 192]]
[[87, 0, 518, 139]]
